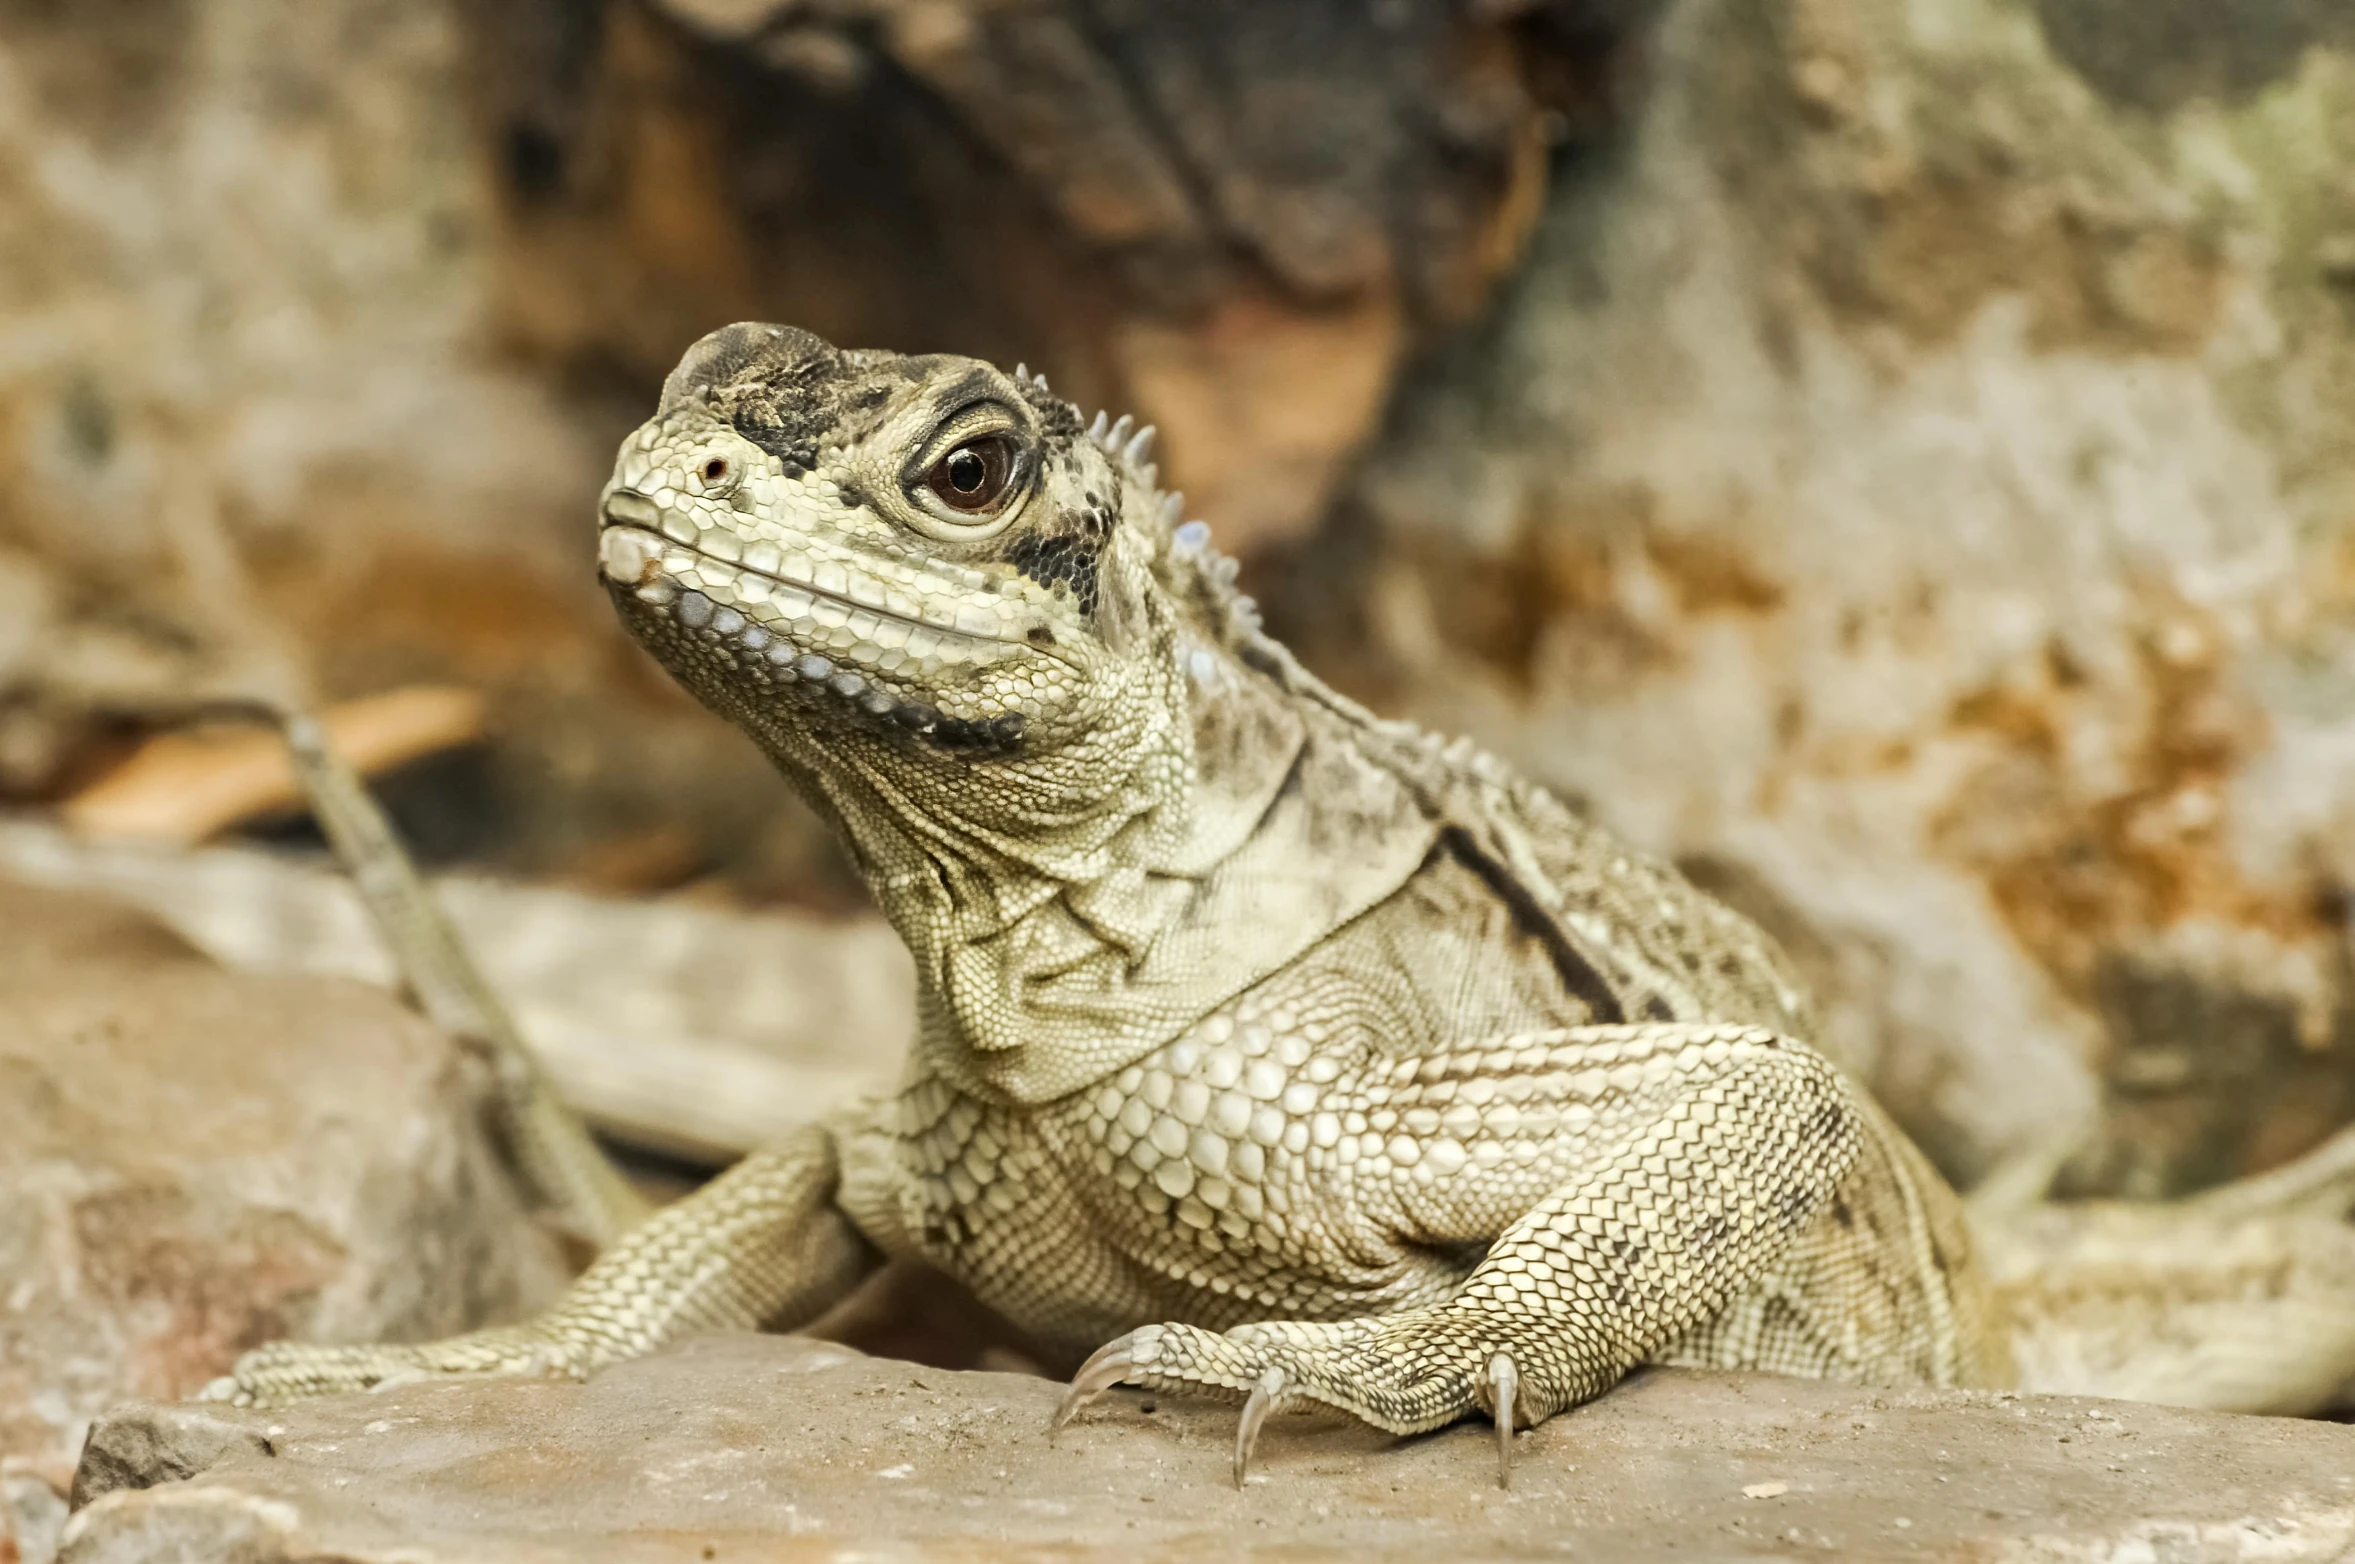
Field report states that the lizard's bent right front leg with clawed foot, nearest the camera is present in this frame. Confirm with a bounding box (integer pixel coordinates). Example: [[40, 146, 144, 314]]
[[1057, 1025, 1858, 1482]]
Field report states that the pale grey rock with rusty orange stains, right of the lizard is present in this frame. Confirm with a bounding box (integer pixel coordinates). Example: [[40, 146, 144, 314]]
[[1309, 0, 2355, 1197]]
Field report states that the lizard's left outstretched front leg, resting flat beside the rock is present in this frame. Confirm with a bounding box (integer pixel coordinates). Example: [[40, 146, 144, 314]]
[[205, 1126, 878, 1406]]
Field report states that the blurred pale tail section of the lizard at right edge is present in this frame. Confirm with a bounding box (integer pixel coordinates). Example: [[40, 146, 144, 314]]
[[1973, 1131, 2355, 1416]]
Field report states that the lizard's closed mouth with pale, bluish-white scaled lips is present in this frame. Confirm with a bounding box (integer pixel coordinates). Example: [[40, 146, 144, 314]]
[[598, 518, 1024, 751]]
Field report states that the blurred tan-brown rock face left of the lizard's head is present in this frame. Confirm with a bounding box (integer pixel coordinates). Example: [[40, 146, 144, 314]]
[[0, 0, 866, 897]]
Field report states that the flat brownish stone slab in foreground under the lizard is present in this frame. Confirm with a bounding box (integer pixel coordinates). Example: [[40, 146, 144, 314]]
[[64, 1336, 2355, 1564]]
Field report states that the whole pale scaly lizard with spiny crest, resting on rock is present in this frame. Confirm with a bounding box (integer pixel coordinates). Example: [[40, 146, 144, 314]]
[[207, 323, 2355, 1482]]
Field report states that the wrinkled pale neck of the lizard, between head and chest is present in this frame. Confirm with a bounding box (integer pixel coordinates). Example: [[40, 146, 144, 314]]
[[787, 655, 1375, 1100]]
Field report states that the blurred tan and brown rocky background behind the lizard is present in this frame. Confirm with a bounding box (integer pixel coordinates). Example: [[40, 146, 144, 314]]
[[0, 0, 2355, 1554]]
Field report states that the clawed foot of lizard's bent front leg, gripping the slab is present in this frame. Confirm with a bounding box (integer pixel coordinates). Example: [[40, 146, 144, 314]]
[[1055, 1310, 1552, 1486]]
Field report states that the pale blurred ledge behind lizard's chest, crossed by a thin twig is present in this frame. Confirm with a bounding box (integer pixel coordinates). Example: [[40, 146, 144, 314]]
[[0, 820, 916, 1166]]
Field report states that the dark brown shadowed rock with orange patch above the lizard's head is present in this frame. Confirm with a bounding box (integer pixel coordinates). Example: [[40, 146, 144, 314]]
[[476, 0, 1656, 546]]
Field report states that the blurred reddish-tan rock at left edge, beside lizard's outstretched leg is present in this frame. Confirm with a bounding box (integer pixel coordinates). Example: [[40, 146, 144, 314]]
[[0, 883, 568, 1559]]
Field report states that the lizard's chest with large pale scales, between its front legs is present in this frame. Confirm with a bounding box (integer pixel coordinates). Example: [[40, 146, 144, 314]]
[[900, 1025, 1481, 1347]]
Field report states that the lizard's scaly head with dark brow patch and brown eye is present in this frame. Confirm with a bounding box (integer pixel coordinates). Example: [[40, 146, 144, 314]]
[[601, 325, 1232, 829]]
